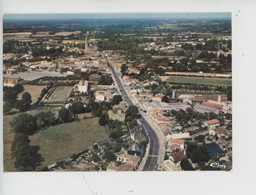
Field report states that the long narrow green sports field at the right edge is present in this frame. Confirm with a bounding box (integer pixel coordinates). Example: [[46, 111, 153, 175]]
[[166, 77, 232, 85]]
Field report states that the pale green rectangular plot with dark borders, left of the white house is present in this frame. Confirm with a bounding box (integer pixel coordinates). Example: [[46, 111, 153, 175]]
[[45, 86, 73, 103]]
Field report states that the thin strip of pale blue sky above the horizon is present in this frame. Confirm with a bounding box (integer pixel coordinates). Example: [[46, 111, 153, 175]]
[[4, 12, 231, 21]]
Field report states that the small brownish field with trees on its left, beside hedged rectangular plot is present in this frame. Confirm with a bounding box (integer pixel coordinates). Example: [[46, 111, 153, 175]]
[[18, 85, 47, 104]]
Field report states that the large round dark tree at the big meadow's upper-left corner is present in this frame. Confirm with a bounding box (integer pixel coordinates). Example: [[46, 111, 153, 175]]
[[10, 113, 37, 135]]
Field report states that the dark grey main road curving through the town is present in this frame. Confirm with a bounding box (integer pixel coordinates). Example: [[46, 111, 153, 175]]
[[110, 65, 160, 171]]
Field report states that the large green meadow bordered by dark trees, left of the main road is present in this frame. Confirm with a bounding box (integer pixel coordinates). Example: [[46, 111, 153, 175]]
[[30, 118, 108, 166]]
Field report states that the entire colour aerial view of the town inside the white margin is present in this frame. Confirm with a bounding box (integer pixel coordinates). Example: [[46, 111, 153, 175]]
[[2, 13, 232, 172]]
